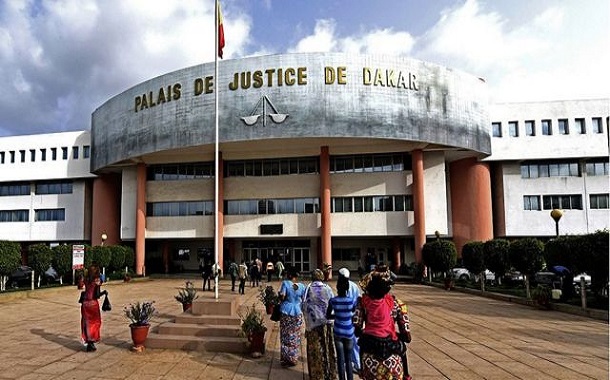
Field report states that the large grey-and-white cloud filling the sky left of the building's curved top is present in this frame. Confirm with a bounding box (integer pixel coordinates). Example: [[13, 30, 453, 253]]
[[0, 0, 251, 136]]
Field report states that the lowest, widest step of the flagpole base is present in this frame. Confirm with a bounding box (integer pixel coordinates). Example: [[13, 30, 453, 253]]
[[146, 332, 248, 354]]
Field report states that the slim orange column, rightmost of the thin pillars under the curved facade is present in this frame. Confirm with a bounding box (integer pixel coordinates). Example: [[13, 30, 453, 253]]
[[411, 149, 426, 263]]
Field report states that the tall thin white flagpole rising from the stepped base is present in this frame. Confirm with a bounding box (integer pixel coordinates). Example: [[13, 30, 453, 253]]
[[214, 0, 220, 299]]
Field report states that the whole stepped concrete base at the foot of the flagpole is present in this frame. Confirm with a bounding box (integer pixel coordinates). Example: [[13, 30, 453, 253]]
[[146, 295, 248, 354]]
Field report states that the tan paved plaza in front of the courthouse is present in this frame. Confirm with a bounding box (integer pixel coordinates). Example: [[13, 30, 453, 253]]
[[0, 278, 609, 380]]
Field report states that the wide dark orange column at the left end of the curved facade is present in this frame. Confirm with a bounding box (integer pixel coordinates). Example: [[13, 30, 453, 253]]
[[91, 174, 121, 246]]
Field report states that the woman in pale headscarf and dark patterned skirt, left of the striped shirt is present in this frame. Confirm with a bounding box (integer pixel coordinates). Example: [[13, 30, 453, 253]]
[[303, 269, 337, 380]]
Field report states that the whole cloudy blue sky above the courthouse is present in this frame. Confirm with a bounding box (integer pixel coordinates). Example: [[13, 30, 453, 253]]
[[0, 0, 610, 137]]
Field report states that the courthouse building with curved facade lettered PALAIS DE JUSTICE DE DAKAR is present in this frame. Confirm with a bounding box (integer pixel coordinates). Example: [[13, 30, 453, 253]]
[[0, 53, 610, 274]]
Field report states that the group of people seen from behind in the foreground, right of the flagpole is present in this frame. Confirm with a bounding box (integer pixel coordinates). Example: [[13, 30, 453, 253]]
[[279, 265, 411, 380]]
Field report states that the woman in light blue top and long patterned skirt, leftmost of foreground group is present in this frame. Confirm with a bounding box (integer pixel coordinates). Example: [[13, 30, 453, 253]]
[[279, 268, 305, 367]]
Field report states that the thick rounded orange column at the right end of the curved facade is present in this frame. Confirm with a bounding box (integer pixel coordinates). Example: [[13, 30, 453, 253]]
[[449, 157, 493, 256]]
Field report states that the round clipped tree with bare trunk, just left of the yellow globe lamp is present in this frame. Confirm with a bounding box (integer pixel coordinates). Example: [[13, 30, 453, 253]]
[[509, 238, 544, 298]]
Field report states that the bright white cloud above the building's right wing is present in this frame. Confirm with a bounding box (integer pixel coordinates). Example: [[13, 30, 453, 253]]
[[415, 0, 610, 101]]
